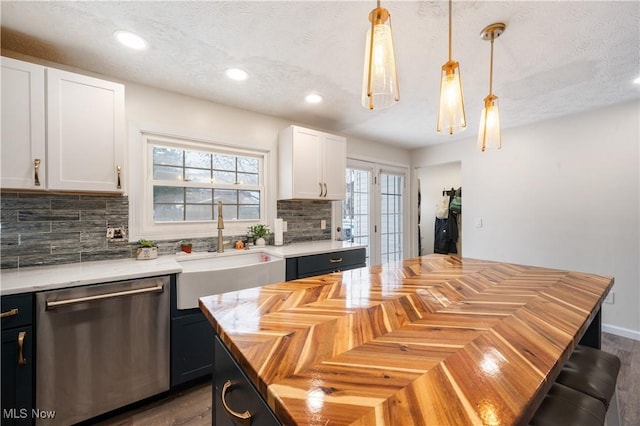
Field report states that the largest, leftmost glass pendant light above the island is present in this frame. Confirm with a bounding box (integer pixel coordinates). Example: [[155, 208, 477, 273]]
[[362, 0, 400, 109]]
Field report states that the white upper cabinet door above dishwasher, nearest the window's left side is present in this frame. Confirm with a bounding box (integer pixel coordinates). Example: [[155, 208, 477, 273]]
[[47, 68, 124, 192]]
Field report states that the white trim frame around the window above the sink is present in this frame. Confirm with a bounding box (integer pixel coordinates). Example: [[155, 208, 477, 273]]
[[129, 130, 269, 241]]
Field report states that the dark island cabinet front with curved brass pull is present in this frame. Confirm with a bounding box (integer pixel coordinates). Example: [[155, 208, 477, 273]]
[[212, 336, 280, 426]]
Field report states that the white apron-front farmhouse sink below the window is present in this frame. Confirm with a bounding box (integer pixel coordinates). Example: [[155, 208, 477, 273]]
[[176, 250, 285, 309]]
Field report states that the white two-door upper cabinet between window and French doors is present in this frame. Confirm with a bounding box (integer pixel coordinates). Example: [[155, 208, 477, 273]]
[[278, 126, 347, 200]]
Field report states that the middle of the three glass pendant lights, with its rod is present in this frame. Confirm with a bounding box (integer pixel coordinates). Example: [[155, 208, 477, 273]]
[[436, 0, 467, 135]]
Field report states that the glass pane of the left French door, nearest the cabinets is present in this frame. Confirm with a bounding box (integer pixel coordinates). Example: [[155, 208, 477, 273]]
[[342, 169, 371, 265]]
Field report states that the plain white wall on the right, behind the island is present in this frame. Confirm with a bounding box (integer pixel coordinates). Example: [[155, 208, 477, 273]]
[[412, 102, 640, 340]]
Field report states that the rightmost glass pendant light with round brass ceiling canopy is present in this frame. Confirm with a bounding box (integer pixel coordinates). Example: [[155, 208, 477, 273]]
[[478, 23, 506, 152]]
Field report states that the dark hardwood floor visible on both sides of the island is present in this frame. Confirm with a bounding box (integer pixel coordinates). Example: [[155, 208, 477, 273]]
[[98, 333, 640, 426]]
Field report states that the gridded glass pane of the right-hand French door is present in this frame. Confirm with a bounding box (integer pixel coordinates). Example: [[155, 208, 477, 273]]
[[380, 172, 404, 263]]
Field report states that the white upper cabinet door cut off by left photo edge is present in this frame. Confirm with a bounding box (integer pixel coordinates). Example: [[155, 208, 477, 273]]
[[0, 57, 47, 189]]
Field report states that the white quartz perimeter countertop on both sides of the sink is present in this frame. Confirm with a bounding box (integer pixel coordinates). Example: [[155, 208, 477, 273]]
[[0, 240, 365, 296]]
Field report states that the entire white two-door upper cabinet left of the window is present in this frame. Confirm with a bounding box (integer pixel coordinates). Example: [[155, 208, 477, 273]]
[[2, 57, 125, 193]]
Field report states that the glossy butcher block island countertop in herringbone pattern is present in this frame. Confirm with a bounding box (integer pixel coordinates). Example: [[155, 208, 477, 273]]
[[200, 255, 613, 426]]
